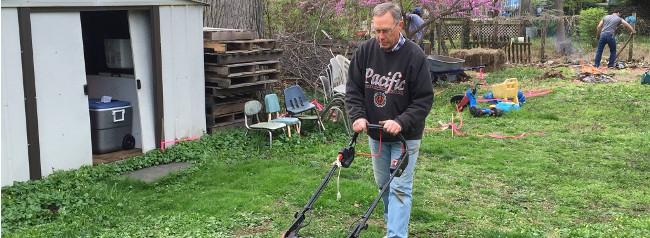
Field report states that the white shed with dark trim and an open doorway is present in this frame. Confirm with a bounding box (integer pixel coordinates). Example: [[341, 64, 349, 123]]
[[1, 0, 205, 186]]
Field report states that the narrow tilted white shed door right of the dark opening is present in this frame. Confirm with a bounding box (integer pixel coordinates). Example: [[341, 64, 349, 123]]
[[129, 10, 156, 152]]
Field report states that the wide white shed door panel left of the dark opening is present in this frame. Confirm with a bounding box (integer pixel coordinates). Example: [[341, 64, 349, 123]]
[[31, 12, 92, 176]]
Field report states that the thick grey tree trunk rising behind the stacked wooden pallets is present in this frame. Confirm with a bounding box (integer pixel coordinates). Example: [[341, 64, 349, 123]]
[[203, 0, 264, 38]]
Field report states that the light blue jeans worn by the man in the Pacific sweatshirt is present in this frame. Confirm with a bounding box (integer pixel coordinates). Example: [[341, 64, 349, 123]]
[[368, 137, 421, 238]]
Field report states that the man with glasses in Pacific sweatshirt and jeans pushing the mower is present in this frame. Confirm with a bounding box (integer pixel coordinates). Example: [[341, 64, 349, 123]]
[[345, 2, 433, 237]]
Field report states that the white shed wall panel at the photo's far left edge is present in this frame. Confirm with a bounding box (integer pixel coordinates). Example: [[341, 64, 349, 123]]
[[1, 8, 29, 186]]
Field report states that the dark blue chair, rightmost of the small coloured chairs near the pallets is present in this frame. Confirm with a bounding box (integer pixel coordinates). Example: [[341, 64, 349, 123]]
[[284, 85, 325, 130]]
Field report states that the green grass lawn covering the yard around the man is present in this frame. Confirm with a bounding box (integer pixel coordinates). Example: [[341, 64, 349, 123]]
[[2, 67, 650, 237]]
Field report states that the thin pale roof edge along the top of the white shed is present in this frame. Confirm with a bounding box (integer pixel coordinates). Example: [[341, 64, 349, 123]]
[[2, 0, 207, 7]]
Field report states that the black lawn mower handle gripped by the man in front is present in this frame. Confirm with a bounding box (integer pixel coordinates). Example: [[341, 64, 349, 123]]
[[282, 124, 408, 238]]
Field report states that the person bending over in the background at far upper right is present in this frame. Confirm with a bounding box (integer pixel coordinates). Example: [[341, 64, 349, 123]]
[[594, 10, 636, 68]]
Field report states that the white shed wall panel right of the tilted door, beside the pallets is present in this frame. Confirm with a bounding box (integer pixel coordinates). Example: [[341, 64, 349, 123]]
[[160, 6, 205, 141]]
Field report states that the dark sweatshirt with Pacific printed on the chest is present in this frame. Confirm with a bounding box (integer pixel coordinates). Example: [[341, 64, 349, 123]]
[[345, 39, 433, 141]]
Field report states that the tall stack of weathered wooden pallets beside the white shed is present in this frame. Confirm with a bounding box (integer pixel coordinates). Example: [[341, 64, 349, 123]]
[[203, 28, 282, 134]]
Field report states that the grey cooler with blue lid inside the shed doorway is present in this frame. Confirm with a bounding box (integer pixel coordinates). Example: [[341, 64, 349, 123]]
[[88, 99, 135, 154]]
